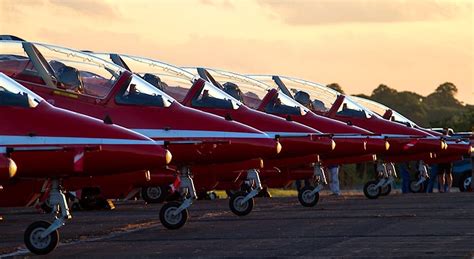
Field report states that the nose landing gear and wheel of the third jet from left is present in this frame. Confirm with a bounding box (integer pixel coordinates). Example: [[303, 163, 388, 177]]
[[229, 169, 262, 216]]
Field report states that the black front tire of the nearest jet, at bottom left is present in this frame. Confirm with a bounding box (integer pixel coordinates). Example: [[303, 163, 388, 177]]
[[24, 221, 59, 255]]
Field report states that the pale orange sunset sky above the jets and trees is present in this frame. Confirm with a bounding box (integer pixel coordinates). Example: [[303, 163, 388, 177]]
[[0, 0, 474, 104]]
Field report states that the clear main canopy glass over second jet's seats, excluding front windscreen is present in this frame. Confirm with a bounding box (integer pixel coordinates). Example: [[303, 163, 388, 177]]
[[0, 41, 123, 98]]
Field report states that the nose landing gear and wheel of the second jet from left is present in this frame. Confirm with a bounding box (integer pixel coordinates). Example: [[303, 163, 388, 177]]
[[160, 167, 197, 232]]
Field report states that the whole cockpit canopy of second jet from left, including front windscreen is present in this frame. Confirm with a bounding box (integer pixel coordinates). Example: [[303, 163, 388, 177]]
[[0, 41, 174, 107]]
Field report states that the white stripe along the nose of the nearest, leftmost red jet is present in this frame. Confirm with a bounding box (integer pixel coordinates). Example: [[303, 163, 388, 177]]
[[0, 135, 164, 146]]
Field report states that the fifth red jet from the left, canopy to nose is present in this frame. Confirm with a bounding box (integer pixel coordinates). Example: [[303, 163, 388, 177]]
[[251, 76, 467, 198]]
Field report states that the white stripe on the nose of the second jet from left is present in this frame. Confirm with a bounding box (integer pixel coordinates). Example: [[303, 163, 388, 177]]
[[132, 129, 270, 139]]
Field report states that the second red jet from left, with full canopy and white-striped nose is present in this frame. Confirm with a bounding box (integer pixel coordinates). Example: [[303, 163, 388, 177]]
[[0, 41, 281, 229]]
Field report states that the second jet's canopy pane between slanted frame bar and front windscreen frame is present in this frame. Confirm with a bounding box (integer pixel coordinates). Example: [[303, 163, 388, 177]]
[[35, 44, 123, 98]]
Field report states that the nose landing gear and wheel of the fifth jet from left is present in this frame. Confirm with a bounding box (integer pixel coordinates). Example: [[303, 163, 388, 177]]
[[364, 161, 397, 199]]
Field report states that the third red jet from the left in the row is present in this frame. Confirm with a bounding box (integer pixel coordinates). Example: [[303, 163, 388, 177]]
[[94, 53, 348, 209]]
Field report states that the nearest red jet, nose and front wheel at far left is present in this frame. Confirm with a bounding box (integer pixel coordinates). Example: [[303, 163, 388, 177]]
[[0, 73, 171, 254]]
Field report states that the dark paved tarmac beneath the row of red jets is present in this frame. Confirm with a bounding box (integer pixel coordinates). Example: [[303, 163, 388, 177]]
[[0, 193, 474, 258]]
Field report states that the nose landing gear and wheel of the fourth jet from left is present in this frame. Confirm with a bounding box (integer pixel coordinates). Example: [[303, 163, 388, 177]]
[[298, 163, 327, 207]]
